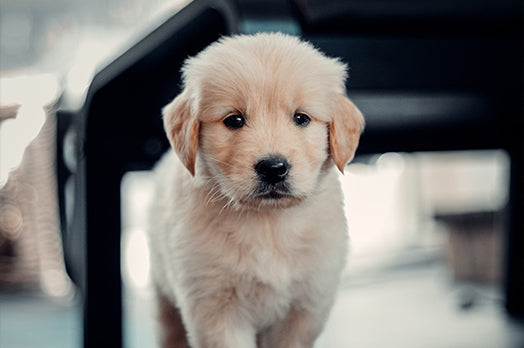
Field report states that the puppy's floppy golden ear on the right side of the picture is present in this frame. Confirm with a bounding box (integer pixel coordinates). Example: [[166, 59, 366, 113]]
[[329, 94, 364, 173]]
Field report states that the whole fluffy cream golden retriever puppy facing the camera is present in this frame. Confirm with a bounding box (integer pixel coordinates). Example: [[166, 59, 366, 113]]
[[149, 34, 364, 348]]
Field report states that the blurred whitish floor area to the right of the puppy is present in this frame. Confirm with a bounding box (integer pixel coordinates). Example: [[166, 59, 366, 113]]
[[318, 266, 524, 348]]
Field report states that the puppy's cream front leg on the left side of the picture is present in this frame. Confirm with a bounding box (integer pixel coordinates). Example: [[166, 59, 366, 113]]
[[183, 290, 256, 348]]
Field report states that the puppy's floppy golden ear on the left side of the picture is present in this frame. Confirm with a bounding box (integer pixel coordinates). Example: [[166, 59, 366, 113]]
[[162, 91, 200, 176]]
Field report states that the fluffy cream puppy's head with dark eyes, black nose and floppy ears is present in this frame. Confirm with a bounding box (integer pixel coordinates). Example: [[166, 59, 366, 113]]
[[163, 34, 364, 208]]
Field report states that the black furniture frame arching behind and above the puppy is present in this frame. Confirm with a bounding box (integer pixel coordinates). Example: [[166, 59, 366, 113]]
[[58, 0, 524, 347]]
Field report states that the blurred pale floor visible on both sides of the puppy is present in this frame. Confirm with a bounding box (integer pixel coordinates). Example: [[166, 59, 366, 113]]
[[0, 264, 524, 348]]
